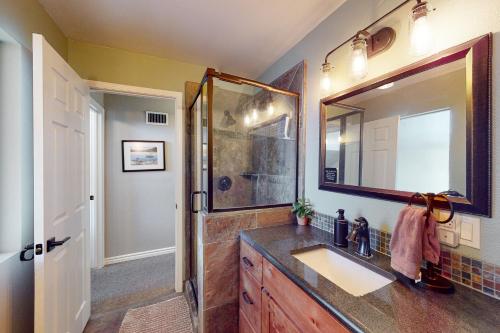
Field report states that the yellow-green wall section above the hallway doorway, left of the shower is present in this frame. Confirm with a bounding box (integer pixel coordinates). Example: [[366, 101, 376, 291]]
[[68, 39, 206, 92]]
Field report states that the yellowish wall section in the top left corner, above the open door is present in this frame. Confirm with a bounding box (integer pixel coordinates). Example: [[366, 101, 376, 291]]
[[0, 0, 68, 59]]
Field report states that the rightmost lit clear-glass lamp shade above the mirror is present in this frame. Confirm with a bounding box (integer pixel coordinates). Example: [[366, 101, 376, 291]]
[[410, 0, 435, 56]]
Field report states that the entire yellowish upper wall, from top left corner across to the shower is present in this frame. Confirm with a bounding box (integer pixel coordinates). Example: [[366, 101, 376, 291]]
[[0, 0, 206, 91]]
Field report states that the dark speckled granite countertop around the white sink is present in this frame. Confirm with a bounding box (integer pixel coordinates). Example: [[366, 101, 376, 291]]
[[241, 225, 500, 333]]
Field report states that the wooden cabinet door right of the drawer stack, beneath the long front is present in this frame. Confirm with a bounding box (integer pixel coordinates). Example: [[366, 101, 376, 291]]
[[262, 291, 300, 333]]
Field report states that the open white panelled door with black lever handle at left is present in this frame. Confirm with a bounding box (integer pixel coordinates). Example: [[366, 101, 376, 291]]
[[33, 34, 90, 333]]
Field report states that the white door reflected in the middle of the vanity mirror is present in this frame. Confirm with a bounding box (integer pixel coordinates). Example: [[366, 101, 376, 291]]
[[362, 116, 399, 189]]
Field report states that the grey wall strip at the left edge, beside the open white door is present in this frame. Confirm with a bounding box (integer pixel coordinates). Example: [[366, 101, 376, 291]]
[[0, 28, 34, 332]]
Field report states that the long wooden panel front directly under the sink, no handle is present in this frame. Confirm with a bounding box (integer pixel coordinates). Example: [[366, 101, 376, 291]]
[[263, 259, 349, 333]]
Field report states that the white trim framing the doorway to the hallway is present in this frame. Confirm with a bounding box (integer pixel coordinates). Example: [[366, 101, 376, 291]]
[[87, 80, 186, 292]]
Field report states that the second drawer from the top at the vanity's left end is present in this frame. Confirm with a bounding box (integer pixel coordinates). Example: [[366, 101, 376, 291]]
[[240, 269, 262, 333]]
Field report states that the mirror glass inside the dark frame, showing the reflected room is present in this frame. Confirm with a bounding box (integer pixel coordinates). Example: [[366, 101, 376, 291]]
[[324, 58, 467, 195]]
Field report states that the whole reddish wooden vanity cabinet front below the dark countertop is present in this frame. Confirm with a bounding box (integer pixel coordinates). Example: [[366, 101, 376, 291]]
[[239, 241, 349, 333]]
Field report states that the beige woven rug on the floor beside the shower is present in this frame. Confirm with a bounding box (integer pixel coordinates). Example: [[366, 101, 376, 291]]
[[120, 296, 193, 333]]
